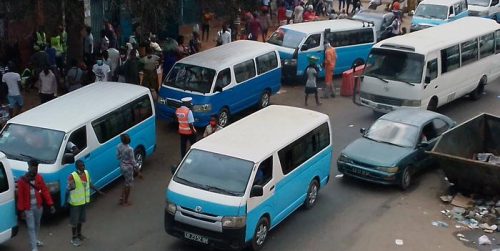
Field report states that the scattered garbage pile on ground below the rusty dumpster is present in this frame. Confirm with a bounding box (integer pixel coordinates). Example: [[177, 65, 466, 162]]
[[440, 193, 500, 233]]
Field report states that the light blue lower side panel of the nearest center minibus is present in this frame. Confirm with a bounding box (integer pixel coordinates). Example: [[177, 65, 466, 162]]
[[245, 146, 333, 241]]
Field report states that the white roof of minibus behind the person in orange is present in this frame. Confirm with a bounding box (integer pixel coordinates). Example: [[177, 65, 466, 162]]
[[280, 19, 371, 34]]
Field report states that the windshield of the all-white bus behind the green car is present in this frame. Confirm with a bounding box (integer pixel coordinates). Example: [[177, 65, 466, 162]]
[[365, 48, 424, 83]]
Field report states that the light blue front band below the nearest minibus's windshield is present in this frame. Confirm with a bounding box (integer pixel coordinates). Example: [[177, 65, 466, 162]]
[[166, 189, 246, 216]]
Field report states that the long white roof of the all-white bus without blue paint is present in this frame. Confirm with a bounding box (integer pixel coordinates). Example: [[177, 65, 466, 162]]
[[373, 17, 500, 55]]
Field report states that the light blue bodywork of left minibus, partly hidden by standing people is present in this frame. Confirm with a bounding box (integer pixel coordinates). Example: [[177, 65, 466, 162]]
[[12, 116, 156, 206]]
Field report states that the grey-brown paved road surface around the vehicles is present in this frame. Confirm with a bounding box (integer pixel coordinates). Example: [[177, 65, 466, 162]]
[[0, 77, 500, 251]]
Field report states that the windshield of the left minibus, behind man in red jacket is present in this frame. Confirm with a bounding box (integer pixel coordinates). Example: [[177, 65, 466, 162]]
[[0, 124, 64, 164]]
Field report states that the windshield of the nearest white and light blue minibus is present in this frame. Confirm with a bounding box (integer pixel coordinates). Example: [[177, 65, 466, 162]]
[[174, 149, 254, 196]]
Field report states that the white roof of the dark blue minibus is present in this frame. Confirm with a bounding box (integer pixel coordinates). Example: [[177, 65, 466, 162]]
[[177, 40, 278, 70]]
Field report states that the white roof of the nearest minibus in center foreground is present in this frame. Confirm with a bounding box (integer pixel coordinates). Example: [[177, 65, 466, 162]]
[[192, 105, 328, 163]]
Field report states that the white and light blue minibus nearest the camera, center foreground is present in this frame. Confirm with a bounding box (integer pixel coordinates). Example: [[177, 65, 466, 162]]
[[165, 105, 333, 250]]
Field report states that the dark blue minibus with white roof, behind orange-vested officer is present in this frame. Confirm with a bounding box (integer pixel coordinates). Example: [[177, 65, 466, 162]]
[[157, 40, 281, 126]]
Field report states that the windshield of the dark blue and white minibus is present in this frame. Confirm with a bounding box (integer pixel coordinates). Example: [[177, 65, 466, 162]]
[[164, 63, 215, 93]]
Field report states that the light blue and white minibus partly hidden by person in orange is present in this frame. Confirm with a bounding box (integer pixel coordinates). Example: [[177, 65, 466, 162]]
[[267, 19, 377, 80]]
